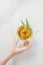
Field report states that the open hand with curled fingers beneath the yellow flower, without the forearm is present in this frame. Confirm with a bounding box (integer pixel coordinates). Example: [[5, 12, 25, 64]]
[[10, 39, 31, 55]]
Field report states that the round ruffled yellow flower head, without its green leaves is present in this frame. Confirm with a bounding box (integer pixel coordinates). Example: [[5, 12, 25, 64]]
[[18, 25, 32, 40]]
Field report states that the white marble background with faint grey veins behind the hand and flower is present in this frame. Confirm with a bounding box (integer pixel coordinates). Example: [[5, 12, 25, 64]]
[[0, 0, 43, 65]]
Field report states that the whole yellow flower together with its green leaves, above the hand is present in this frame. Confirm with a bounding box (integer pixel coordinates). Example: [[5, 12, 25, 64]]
[[17, 18, 32, 40]]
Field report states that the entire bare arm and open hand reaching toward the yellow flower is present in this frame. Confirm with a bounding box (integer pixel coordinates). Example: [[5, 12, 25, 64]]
[[0, 39, 31, 65]]
